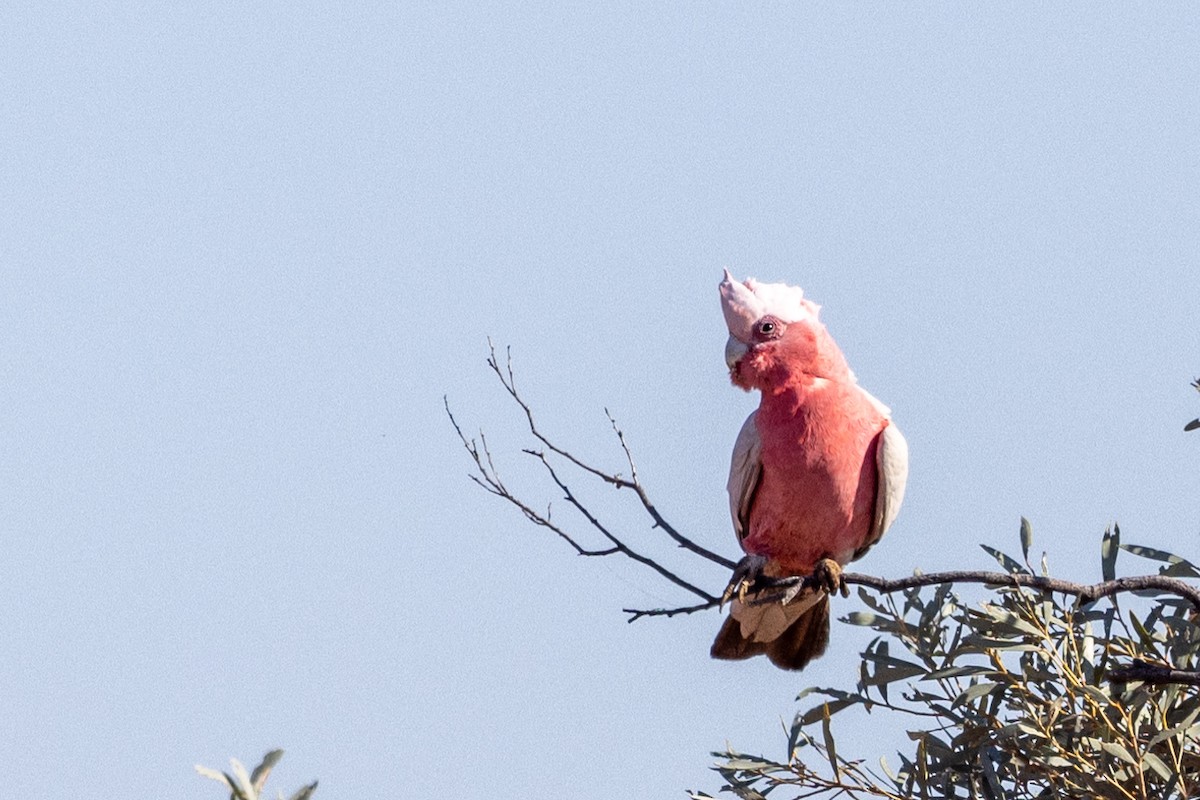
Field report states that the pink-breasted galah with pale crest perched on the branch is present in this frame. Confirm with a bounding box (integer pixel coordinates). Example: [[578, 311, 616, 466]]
[[712, 270, 908, 669]]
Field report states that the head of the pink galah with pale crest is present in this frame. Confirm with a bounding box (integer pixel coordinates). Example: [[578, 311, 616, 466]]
[[720, 270, 850, 390]]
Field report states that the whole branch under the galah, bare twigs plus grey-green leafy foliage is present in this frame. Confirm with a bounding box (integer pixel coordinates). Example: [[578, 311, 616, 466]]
[[446, 348, 1200, 800]]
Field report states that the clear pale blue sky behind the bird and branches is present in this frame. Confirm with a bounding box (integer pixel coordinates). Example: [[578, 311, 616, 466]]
[[0, 2, 1200, 800]]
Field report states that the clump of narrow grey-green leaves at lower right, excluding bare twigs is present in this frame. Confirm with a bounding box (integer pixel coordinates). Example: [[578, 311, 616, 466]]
[[691, 519, 1200, 799]]
